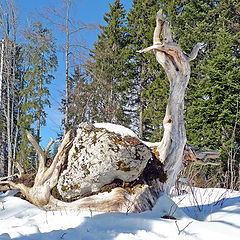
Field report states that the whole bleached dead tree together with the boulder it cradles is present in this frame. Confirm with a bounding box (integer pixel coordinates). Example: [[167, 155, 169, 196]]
[[0, 10, 206, 212]]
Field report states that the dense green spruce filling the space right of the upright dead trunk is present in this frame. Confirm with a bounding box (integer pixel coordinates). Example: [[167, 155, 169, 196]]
[[165, 0, 240, 186]]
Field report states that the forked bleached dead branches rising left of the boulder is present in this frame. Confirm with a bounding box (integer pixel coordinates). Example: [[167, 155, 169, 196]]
[[0, 132, 71, 208]]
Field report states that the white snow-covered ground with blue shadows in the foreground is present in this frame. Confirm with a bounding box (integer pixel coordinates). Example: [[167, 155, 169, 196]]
[[0, 187, 240, 240]]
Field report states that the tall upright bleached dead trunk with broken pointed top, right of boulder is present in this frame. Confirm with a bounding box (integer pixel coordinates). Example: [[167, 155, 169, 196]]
[[139, 10, 204, 192]]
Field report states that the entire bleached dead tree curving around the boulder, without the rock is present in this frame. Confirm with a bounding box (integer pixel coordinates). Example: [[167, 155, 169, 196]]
[[0, 10, 203, 212]]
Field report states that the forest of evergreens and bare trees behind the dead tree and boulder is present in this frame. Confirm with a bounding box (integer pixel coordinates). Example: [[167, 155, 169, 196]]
[[0, 0, 240, 190]]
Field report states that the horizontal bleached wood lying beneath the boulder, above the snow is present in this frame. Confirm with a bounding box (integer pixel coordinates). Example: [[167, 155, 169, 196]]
[[43, 181, 162, 213]]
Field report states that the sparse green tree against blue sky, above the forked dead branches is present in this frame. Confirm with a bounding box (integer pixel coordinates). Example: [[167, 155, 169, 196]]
[[23, 22, 57, 141]]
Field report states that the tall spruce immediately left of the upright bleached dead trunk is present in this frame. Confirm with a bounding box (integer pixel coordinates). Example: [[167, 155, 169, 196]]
[[127, 0, 169, 141]]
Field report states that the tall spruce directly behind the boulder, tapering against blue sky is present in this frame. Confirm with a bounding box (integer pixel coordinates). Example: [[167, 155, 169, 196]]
[[86, 0, 129, 125]]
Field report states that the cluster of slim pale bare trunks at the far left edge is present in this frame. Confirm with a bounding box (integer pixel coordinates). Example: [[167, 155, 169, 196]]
[[0, 0, 21, 175]]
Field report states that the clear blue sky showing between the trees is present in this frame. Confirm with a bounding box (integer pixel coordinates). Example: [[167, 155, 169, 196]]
[[15, 0, 132, 147]]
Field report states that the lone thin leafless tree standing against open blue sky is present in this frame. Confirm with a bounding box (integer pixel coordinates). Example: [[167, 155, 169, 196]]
[[43, 0, 90, 135]]
